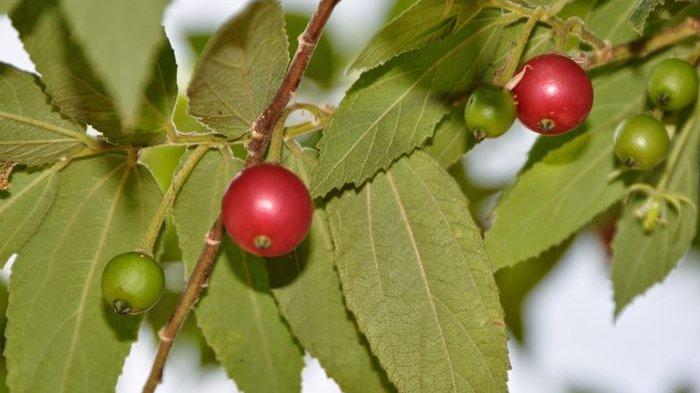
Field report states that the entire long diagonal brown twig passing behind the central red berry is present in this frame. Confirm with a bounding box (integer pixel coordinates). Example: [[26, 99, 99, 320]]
[[143, 0, 340, 393]]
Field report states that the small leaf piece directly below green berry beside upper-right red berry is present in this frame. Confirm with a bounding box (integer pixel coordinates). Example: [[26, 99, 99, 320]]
[[422, 106, 475, 168]]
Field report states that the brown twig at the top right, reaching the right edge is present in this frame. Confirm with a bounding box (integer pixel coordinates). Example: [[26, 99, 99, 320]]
[[584, 17, 700, 69]]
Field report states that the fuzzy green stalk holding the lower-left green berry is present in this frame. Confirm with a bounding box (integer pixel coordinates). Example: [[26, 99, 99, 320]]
[[139, 145, 211, 256]]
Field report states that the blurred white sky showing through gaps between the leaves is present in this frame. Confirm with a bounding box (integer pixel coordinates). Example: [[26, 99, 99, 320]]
[[0, 0, 700, 393]]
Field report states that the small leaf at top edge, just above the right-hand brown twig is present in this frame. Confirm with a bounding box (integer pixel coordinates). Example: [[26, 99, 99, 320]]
[[586, 0, 639, 44]]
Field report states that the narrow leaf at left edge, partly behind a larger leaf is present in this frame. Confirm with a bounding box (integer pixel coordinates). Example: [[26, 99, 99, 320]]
[[0, 168, 56, 266]]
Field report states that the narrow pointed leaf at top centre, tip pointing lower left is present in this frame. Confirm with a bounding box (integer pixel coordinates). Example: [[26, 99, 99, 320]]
[[350, 0, 482, 71]]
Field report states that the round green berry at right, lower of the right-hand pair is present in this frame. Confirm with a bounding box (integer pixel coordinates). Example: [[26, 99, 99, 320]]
[[615, 114, 671, 171]]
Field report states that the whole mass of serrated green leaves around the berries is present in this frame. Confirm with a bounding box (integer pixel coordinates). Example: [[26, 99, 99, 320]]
[[0, 0, 700, 392]]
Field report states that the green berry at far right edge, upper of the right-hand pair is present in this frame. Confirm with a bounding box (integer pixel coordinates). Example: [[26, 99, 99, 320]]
[[647, 59, 698, 111]]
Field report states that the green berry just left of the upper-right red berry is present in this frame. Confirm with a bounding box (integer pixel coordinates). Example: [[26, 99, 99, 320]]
[[464, 86, 515, 141]]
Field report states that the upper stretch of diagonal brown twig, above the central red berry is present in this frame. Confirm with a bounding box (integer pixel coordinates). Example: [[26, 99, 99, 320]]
[[246, 0, 340, 166]]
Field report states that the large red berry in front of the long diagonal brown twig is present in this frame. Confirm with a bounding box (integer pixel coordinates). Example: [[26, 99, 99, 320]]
[[221, 164, 313, 257]]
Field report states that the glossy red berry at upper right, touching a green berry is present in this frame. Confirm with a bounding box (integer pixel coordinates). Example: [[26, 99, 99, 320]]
[[513, 54, 593, 135]]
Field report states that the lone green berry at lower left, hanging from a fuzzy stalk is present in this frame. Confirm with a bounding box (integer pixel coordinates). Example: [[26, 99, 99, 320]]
[[102, 252, 165, 314]]
